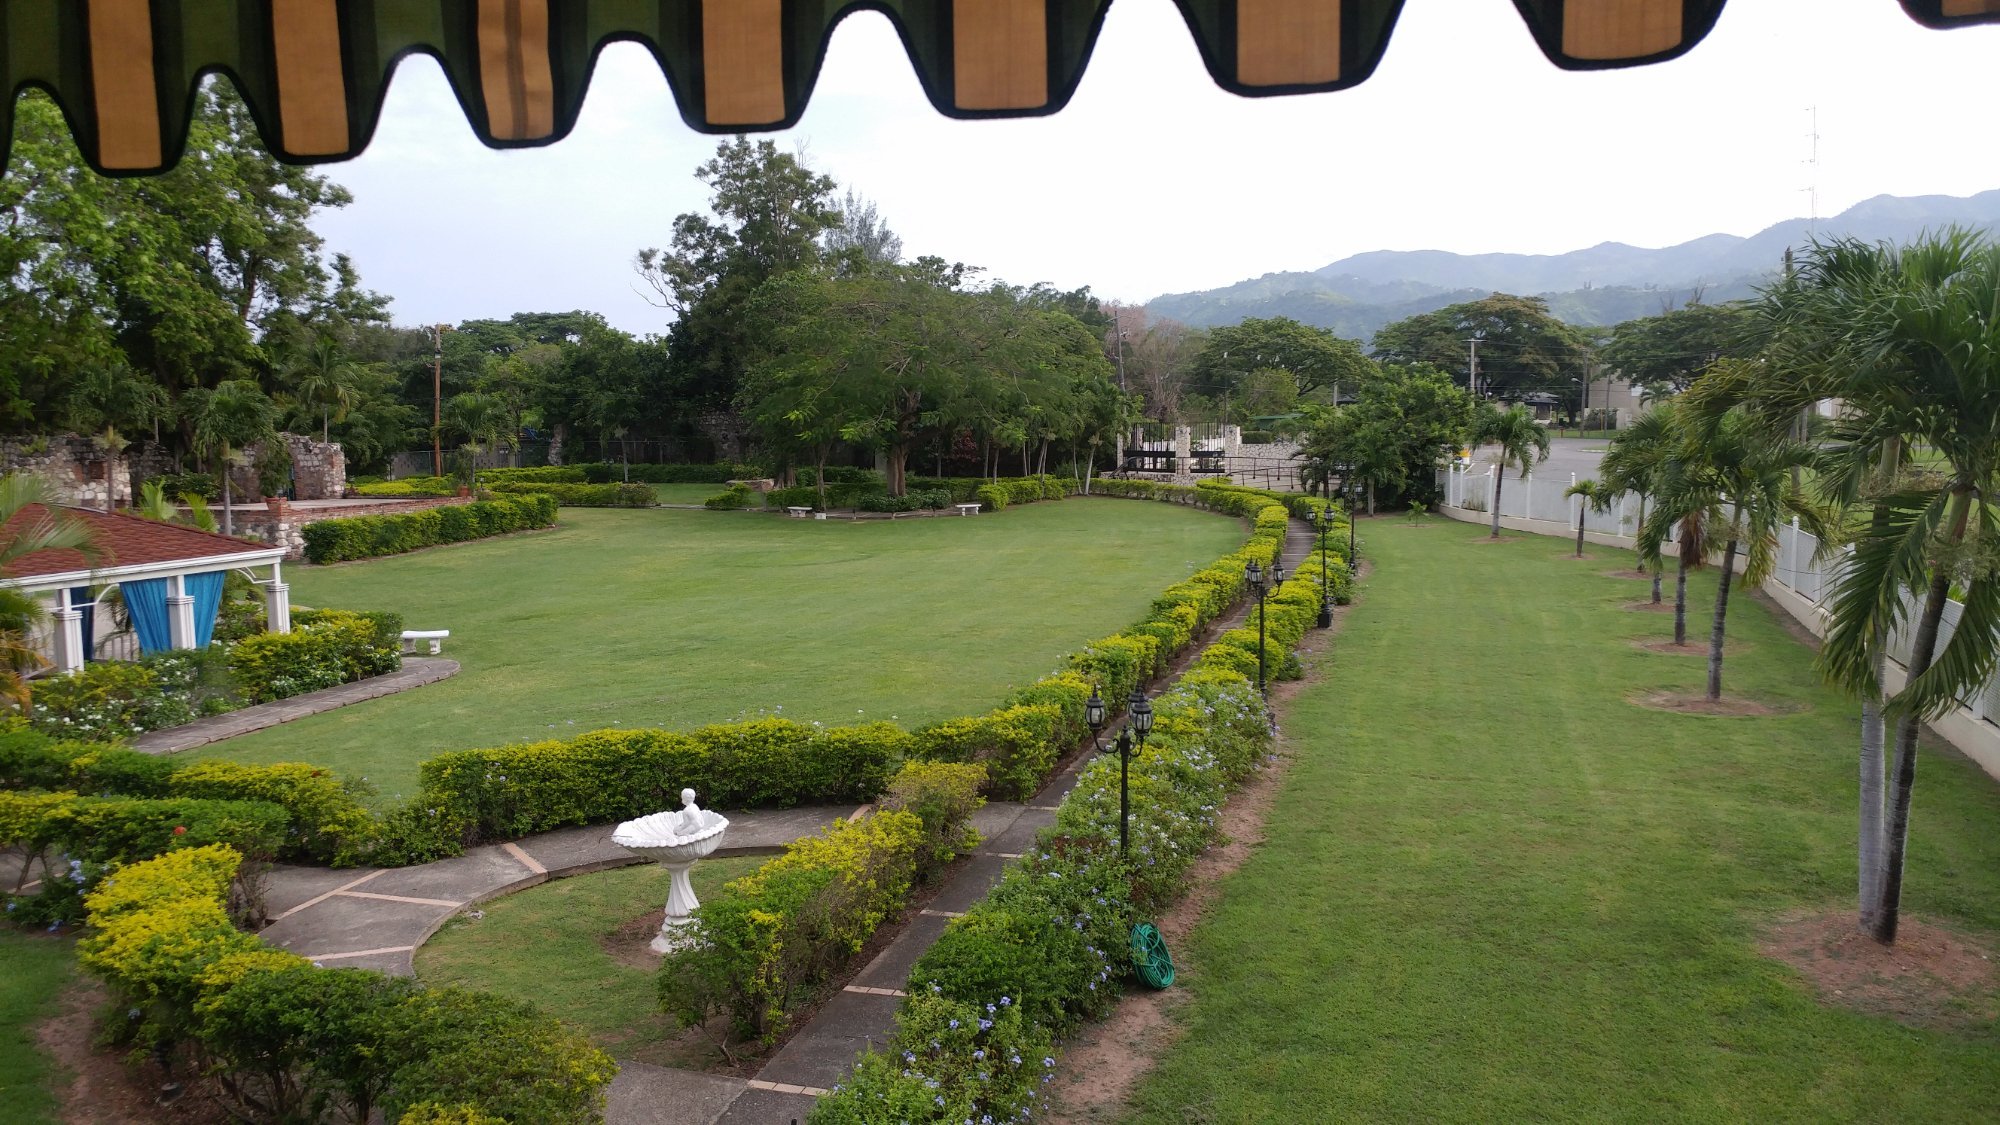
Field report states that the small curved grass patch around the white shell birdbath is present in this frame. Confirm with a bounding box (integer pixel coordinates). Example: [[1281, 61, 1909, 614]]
[[416, 857, 764, 1069]]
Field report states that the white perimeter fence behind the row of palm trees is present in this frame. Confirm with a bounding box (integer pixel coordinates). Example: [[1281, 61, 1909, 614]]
[[1440, 464, 2000, 725]]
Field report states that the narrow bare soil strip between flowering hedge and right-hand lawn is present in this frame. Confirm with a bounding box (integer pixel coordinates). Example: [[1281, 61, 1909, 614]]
[[1042, 560, 1370, 1125]]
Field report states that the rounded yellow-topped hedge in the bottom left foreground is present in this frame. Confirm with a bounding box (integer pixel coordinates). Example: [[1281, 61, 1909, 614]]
[[78, 845, 616, 1125]]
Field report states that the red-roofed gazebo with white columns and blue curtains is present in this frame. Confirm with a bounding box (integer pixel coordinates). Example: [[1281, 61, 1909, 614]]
[[0, 504, 292, 671]]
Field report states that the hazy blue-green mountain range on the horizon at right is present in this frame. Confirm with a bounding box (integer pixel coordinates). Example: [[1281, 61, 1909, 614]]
[[1146, 190, 2000, 340]]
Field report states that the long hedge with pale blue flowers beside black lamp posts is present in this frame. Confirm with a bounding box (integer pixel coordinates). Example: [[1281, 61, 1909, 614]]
[[810, 567, 1322, 1125]]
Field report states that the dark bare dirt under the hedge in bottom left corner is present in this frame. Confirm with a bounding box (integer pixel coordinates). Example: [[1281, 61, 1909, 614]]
[[34, 979, 228, 1125]]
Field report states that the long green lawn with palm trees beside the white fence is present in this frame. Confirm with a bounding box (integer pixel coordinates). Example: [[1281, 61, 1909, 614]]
[[1134, 520, 2000, 1123]]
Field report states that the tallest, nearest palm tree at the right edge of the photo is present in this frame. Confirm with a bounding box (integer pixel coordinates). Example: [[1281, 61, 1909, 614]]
[[1766, 228, 2000, 943]]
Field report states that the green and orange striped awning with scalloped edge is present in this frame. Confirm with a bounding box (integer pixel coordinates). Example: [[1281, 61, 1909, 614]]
[[0, 0, 2000, 174]]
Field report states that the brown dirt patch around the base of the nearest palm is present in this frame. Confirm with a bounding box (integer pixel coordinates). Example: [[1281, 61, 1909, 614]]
[[1758, 907, 2000, 1031]]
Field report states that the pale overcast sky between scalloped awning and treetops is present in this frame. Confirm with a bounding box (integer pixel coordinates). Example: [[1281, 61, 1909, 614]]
[[320, 0, 2000, 334]]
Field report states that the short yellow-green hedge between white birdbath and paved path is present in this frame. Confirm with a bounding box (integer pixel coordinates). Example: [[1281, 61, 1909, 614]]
[[660, 763, 986, 1043]]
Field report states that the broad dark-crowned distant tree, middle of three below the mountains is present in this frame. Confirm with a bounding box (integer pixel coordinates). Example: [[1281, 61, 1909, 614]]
[[1372, 292, 1588, 400]]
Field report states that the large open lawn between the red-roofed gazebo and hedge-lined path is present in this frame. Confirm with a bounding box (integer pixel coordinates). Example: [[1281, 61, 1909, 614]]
[[194, 498, 1244, 799]]
